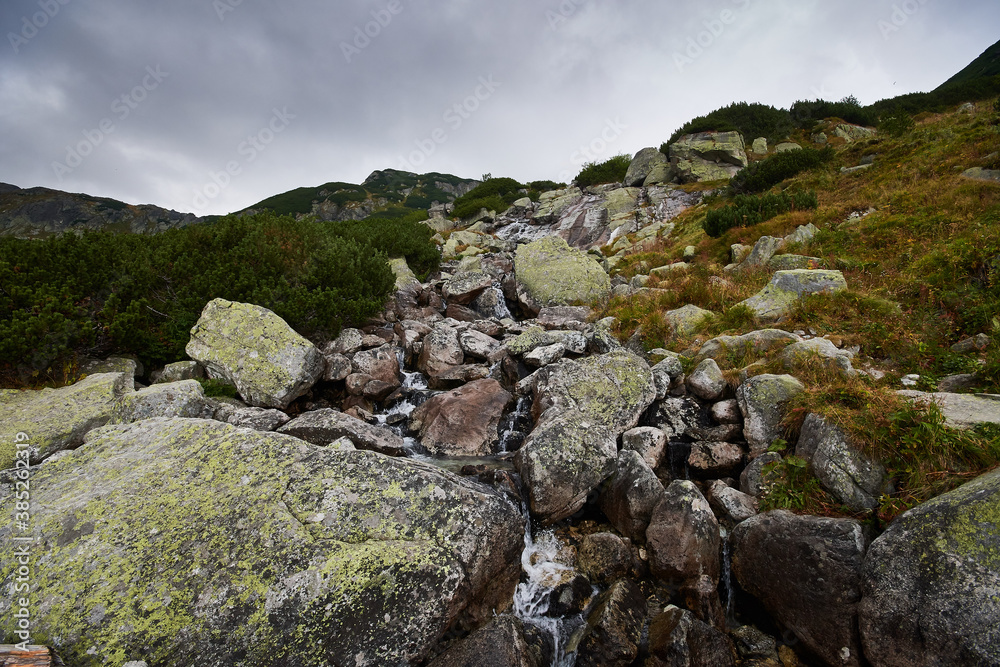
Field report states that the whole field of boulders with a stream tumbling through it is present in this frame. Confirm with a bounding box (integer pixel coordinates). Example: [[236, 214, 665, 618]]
[[0, 147, 1000, 667]]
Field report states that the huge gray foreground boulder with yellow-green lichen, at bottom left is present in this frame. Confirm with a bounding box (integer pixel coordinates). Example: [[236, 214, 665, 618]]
[[0, 419, 524, 667]]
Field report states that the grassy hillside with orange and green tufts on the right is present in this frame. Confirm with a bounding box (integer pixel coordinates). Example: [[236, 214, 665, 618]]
[[604, 100, 1000, 519]]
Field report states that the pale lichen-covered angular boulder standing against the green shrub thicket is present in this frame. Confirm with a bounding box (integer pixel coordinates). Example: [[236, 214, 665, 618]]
[[185, 299, 324, 410]]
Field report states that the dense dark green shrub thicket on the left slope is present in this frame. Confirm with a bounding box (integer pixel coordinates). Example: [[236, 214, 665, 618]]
[[0, 213, 399, 380]]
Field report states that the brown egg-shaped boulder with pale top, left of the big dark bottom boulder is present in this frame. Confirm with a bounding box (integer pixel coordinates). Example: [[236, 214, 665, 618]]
[[646, 480, 722, 585]]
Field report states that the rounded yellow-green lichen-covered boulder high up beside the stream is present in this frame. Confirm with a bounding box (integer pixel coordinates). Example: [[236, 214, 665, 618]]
[[514, 236, 611, 313]]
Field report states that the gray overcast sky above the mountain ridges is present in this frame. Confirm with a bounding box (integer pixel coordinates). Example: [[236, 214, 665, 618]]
[[0, 0, 1000, 214]]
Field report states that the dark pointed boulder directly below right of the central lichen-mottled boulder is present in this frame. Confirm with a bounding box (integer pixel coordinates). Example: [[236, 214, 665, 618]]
[[600, 449, 663, 542]]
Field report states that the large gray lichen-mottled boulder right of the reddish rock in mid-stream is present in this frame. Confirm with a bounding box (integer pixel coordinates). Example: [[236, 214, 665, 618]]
[[515, 350, 656, 522]]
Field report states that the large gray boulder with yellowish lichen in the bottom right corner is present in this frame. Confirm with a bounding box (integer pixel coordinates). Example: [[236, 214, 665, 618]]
[[859, 470, 1000, 667]]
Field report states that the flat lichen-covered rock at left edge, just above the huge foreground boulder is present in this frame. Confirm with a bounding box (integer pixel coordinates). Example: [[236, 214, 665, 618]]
[[0, 373, 135, 470]]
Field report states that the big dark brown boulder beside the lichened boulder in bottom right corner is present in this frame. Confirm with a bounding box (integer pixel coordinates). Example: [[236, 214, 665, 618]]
[[731, 510, 867, 666]]
